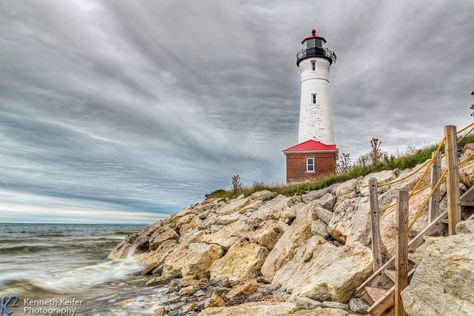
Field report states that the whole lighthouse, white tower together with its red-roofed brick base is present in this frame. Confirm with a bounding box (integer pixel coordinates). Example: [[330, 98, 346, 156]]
[[283, 28, 338, 183]]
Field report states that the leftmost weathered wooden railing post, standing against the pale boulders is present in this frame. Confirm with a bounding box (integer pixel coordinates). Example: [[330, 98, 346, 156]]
[[369, 178, 383, 271]]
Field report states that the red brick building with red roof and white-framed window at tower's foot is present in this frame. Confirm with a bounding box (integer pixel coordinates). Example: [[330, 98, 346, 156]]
[[283, 139, 338, 183]]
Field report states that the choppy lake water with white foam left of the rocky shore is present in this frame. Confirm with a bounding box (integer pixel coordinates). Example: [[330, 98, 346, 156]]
[[0, 224, 169, 316]]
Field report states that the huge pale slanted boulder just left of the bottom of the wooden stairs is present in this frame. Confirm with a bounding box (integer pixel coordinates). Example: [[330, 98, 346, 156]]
[[273, 236, 373, 303]]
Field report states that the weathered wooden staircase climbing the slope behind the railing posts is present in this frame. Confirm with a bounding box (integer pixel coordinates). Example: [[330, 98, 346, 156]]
[[356, 186, 474, 315]]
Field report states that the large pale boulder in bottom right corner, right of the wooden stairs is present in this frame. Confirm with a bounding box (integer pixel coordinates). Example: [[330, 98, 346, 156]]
[[401, 234, 474, 316]]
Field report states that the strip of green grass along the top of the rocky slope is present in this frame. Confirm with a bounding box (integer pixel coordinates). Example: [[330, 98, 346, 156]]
[[206, 135, 474, 199]]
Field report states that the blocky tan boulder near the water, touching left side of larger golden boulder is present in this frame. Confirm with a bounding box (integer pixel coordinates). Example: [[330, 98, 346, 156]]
[[182, 243, 224, 279]]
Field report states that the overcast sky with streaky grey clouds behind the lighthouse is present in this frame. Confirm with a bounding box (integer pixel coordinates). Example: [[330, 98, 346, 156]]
[[0, 0, 474, 222]]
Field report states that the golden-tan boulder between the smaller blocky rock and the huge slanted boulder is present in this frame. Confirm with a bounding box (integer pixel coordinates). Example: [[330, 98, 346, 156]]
[[210, 239, 268, 283]]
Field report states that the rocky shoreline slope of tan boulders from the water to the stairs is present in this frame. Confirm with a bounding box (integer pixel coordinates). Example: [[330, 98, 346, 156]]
[[110, 147, 474, 316]]
